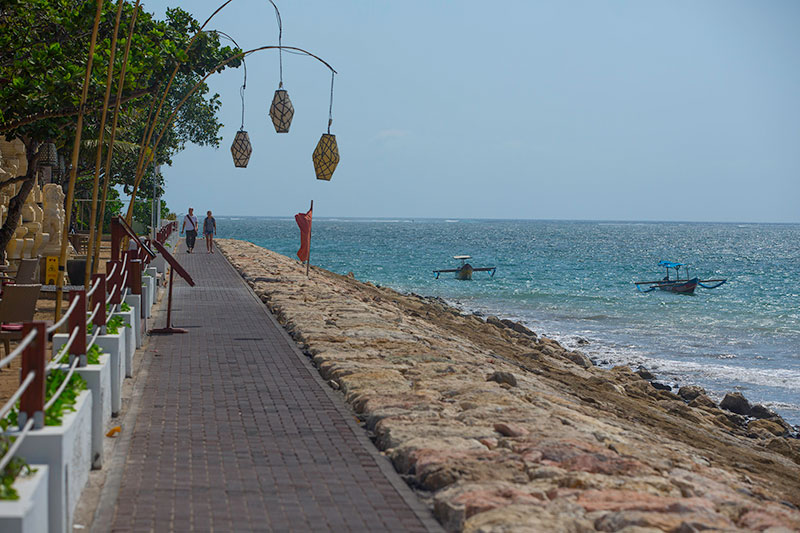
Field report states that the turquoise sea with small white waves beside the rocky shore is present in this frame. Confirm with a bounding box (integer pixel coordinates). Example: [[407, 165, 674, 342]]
[[217, 217, 800, 424]]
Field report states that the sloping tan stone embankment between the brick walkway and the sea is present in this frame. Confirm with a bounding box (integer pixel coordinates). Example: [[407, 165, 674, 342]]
[[219, 240, 800, 533]]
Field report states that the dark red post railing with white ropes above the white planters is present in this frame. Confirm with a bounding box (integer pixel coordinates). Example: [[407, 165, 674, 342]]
[[0, 214, 172, 471]]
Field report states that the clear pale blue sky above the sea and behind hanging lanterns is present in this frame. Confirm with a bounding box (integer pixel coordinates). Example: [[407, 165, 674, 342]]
[[144, 0, 800, 223]]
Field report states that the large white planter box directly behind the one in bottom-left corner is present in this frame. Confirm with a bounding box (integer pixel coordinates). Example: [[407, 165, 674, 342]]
[[11, 390, 92, 533]]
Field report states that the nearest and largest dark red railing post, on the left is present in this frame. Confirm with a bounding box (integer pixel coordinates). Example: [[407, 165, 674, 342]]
[[17, 322, 47, 429]]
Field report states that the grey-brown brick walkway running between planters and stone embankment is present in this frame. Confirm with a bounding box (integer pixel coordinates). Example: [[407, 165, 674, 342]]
[[106, 239, 438, 531]]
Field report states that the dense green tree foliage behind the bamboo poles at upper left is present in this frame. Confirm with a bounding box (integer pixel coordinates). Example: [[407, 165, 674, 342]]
[[0, 0, 241, 250]]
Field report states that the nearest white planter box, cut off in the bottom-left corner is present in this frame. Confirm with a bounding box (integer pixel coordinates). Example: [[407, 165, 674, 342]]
[[0, 464, 48, 533]]
